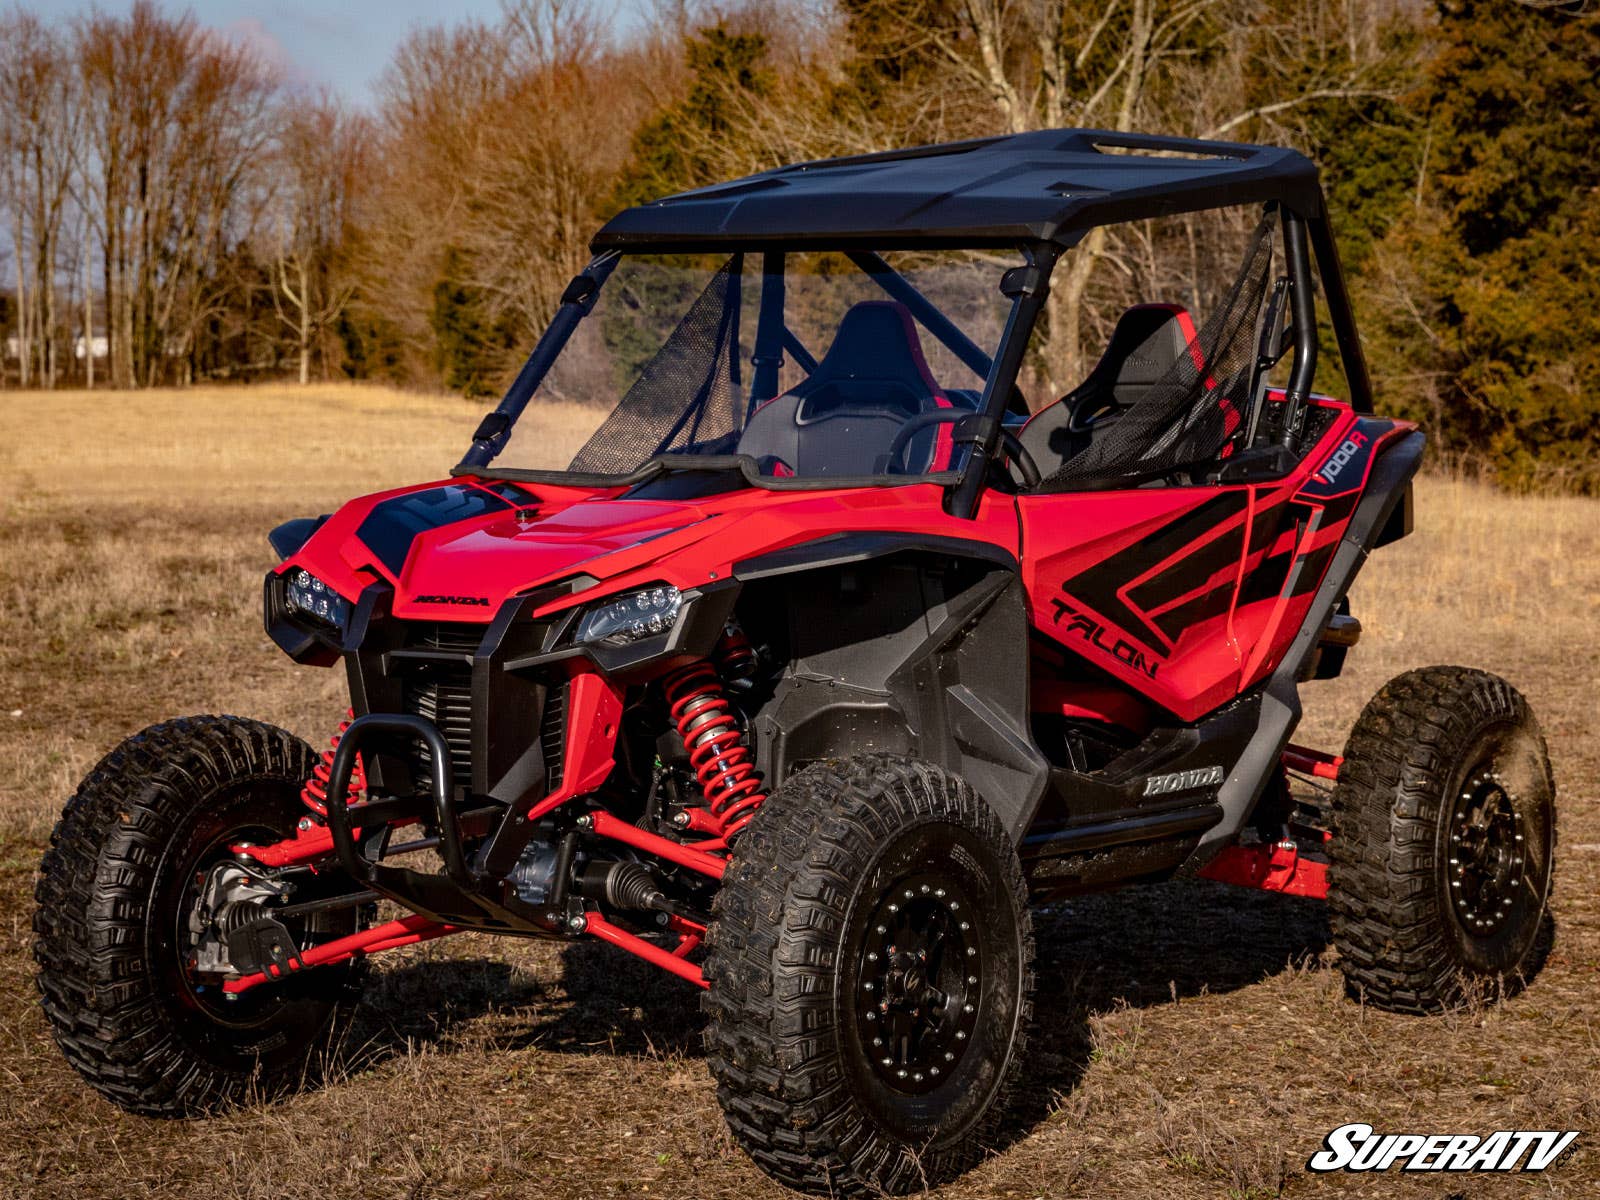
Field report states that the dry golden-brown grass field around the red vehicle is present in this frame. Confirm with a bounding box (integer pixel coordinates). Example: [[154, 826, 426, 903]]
[[0, 387, 1600, 1200]]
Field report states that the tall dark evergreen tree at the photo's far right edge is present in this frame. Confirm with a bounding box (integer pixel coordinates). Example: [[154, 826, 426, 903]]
[[1392, 0, 1600, 491]]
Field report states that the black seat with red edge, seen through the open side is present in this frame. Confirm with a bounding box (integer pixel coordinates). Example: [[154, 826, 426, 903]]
[[1018, 304, 1202, 477]]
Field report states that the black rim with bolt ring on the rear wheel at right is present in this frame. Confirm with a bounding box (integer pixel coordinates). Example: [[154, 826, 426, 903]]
[[1445, 768, 1526, 938]]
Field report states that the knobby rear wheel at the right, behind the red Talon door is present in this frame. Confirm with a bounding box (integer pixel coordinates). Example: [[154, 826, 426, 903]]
[[1328, 667, 1555, 1013]]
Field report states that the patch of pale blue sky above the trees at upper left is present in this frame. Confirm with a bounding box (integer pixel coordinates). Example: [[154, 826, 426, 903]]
[[22, 0, 515, 102]]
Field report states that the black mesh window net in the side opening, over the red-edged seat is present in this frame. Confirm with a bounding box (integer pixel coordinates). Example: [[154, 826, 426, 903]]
[[1038, 216, 1277, 491]]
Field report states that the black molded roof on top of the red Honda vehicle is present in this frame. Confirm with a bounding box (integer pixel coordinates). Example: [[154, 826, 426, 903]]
[[592, 130, 1322, 251]]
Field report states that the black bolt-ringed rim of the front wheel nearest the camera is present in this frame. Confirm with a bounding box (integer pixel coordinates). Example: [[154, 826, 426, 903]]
[[854, 875, 986, 1094]]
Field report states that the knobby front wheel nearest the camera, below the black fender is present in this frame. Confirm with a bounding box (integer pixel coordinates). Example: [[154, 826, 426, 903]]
[[706, 755, 1034, 1195]]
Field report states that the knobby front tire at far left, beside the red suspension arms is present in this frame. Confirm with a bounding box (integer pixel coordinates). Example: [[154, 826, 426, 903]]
[[34, 717, 360, 1117]]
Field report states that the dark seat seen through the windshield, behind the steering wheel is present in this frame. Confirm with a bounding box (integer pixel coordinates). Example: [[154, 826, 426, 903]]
[[738, 301, 952, 478]]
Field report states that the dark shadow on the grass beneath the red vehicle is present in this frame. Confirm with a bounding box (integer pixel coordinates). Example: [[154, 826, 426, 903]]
[[324, 882, 1328, 1139]]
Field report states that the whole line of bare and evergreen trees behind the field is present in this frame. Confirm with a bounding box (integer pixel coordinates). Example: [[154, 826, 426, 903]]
[[0, 0, 1600, 491]]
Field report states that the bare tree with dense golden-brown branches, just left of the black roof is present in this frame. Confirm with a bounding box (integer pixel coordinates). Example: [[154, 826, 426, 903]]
[[360, 0, 659, 380]]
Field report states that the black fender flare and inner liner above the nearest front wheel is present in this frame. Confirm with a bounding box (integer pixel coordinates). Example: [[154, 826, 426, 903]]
[[734, 533, 1050, 843]]
